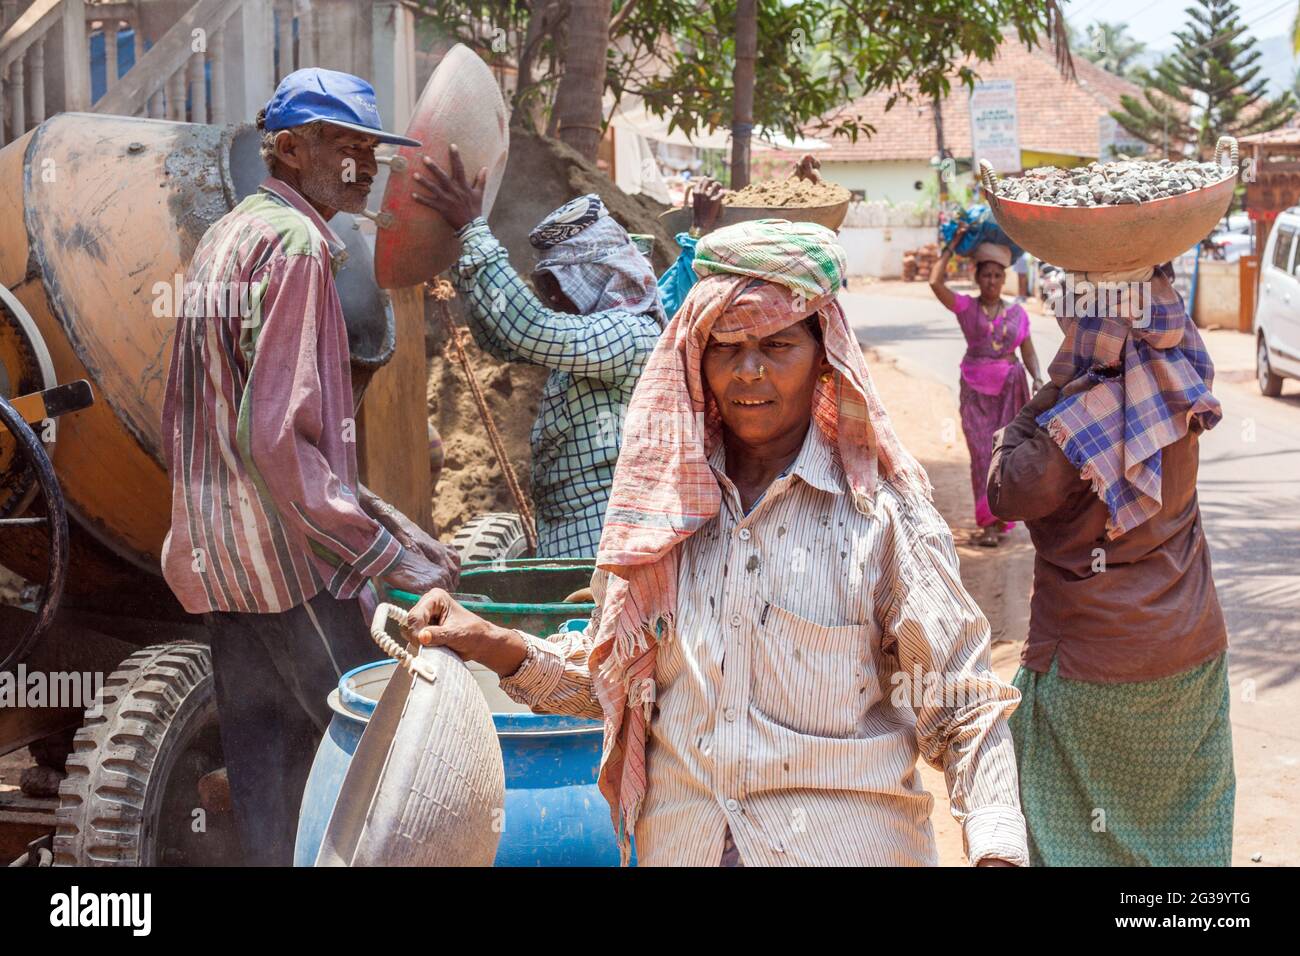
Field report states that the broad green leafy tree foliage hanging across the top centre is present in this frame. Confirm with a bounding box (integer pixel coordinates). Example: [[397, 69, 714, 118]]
[[410, 0, 1073, 138]]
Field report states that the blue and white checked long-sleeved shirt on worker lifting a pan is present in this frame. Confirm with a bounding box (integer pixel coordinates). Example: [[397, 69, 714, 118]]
[[451, 216, 659, 558]]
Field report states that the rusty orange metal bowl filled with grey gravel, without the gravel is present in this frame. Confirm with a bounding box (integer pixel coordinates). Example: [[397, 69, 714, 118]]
[[982, 137, 1238, 272]]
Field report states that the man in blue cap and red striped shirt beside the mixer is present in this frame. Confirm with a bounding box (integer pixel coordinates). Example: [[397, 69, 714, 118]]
[[163, 69, 459, 865]]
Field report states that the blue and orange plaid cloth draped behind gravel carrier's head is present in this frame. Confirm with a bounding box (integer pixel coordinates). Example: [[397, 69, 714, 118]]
[[1037, 265, 1223, 538]]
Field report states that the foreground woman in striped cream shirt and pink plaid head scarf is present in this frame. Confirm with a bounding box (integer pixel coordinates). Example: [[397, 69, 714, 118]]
[[403, 220, 1026, 866]]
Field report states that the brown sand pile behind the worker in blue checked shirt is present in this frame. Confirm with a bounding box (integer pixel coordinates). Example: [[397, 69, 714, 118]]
[[425, 127, 679, 541]]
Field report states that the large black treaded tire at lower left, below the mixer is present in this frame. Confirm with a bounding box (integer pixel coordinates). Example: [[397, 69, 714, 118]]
[[55, 643, 239, 866]]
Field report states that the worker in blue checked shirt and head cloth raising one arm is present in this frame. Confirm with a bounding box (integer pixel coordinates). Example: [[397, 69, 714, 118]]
[[415, 152, 664, 558]]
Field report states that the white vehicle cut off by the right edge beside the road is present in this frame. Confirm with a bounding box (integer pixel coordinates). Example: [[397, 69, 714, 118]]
[[1255, 207, 1300, 397]]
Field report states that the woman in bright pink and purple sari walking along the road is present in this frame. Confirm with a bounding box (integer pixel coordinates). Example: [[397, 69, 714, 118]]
[[930, 238, 1043, 548]]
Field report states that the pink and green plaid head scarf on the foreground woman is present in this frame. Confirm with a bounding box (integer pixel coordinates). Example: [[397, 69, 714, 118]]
[[589, 220, 930, 861]]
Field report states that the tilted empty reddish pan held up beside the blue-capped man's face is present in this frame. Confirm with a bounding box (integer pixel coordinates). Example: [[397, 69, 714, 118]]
[[374, 43, 510, 289]]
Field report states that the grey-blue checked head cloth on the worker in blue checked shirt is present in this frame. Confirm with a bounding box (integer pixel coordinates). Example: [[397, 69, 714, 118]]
[[528, 193, 667, 326]]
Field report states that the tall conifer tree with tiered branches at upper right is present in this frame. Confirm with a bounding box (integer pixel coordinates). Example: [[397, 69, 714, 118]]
[[1112, 0, 1295, 159]]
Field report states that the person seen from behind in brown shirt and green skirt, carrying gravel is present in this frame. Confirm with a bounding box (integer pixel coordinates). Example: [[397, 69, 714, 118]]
[[988, 265, 1235, 866]]
